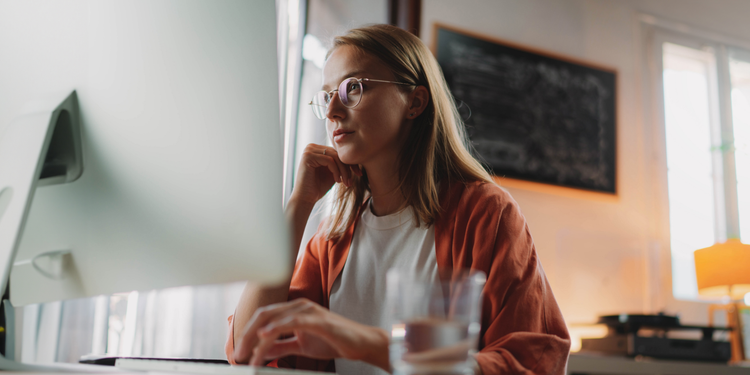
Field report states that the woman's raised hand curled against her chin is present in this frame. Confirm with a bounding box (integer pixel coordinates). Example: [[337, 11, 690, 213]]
[[292, 143, 362, 209]]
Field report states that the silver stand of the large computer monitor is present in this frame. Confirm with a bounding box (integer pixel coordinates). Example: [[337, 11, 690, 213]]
[[0, 91, 97, 372]]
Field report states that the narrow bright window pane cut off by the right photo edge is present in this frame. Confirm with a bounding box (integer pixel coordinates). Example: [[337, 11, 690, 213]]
[[729, 54, 750, 243]]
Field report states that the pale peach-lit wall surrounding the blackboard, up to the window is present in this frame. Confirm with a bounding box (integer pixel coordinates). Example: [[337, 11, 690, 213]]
[[421, 0, 750, 324]]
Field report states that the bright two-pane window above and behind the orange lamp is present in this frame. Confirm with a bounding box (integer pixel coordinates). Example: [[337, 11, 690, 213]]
[[656, 33, 750, 300]]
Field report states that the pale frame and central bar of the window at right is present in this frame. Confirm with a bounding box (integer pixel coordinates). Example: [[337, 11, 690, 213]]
[[636, 14, 750, 310]]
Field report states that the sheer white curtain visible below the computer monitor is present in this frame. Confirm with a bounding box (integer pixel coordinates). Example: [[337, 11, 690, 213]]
[[17, 283, 244, 363]]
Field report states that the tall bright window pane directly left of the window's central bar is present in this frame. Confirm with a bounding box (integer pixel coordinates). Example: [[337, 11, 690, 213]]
[[663, 43, 715, 299]]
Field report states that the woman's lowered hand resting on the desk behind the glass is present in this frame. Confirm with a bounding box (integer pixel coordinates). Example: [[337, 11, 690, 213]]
[[235, 299, 390, 371]]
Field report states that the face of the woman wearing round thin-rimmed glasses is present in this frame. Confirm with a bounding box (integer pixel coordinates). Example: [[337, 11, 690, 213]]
[[323, 46, 409, 167]]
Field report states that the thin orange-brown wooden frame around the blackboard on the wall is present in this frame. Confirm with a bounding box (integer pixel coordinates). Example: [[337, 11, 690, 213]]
[[431, 22, 620, 202]]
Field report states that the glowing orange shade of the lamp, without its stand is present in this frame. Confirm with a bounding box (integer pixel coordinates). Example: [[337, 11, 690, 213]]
[[693, 239, 750, 300]]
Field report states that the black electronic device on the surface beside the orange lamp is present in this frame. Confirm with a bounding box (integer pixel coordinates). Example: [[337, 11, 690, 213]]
[[581, 314, 732, 362]]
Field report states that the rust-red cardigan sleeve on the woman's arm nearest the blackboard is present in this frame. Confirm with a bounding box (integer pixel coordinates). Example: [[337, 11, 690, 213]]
[[468, 187, 570, 375]]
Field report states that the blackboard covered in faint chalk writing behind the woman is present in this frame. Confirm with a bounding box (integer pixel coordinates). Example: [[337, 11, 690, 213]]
[[436, 26, 617, 194]]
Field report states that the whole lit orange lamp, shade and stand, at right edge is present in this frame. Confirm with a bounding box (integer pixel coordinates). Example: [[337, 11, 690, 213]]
[[694, 239, 750, 362]]
